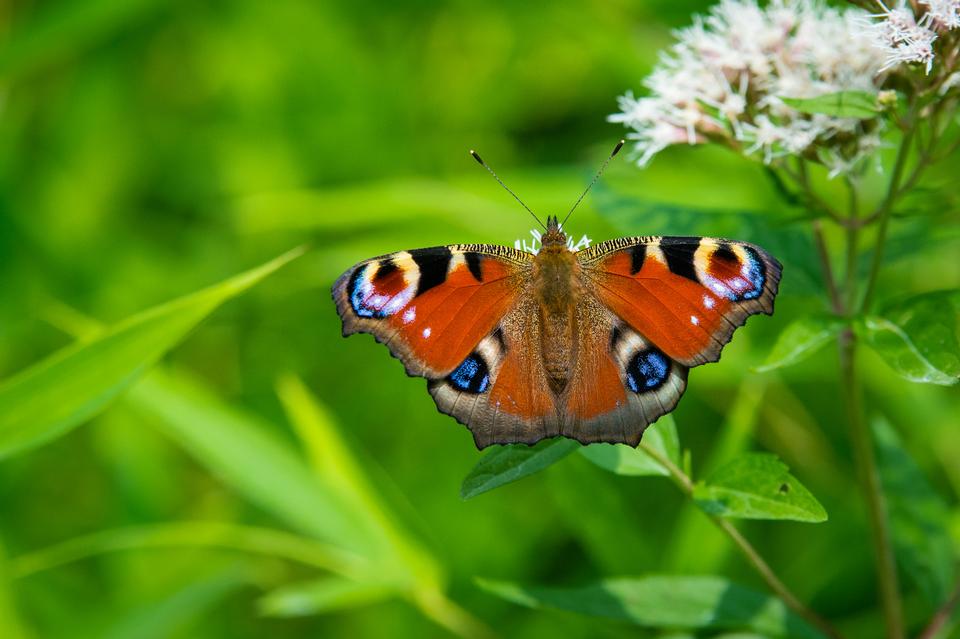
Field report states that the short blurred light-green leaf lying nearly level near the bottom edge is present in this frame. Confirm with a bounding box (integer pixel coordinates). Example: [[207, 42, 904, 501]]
[[257, 577, 397, 617]]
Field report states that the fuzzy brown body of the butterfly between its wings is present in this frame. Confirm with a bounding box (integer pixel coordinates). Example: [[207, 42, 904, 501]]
[[533, 219, 581, 395]]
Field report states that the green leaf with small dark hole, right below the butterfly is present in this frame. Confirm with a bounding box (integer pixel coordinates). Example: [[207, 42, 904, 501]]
[[693, 453, 827, 522]]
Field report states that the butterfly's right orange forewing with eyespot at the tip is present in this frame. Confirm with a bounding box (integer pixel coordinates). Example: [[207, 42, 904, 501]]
[[577, 237, 781, 366]]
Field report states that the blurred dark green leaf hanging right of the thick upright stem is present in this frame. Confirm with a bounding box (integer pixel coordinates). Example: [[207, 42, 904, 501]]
[[873, 419, 955, 606]]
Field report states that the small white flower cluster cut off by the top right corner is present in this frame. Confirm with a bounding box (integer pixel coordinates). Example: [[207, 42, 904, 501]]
[[869, 0, 960, 73]]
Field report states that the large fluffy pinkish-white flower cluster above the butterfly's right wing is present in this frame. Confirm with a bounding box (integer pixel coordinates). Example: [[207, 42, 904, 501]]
[[609, 0, 883, 174]]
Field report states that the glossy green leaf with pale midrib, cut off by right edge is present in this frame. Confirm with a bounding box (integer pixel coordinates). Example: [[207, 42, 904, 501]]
[[861, 291, 960, 386]]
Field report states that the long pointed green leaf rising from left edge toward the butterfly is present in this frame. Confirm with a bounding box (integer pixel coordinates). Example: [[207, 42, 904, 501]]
[[0, 249, 303, 458]]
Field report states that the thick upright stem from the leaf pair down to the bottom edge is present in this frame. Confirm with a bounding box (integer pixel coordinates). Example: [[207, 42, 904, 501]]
[[839, 327, 904, 639]]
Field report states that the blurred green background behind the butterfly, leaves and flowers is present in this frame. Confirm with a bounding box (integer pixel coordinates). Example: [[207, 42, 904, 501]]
[[0, 0, 960, 637]]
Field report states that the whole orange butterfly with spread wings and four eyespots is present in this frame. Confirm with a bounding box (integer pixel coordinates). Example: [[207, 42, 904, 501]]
[[333, 146, 781, 449]]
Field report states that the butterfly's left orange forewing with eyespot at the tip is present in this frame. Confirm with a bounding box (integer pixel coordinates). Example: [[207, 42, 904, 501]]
[[333, 244, 531, 379]]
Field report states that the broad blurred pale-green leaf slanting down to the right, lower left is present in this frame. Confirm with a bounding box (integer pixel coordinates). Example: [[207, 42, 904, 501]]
[[127, 370, 383, 559]]
